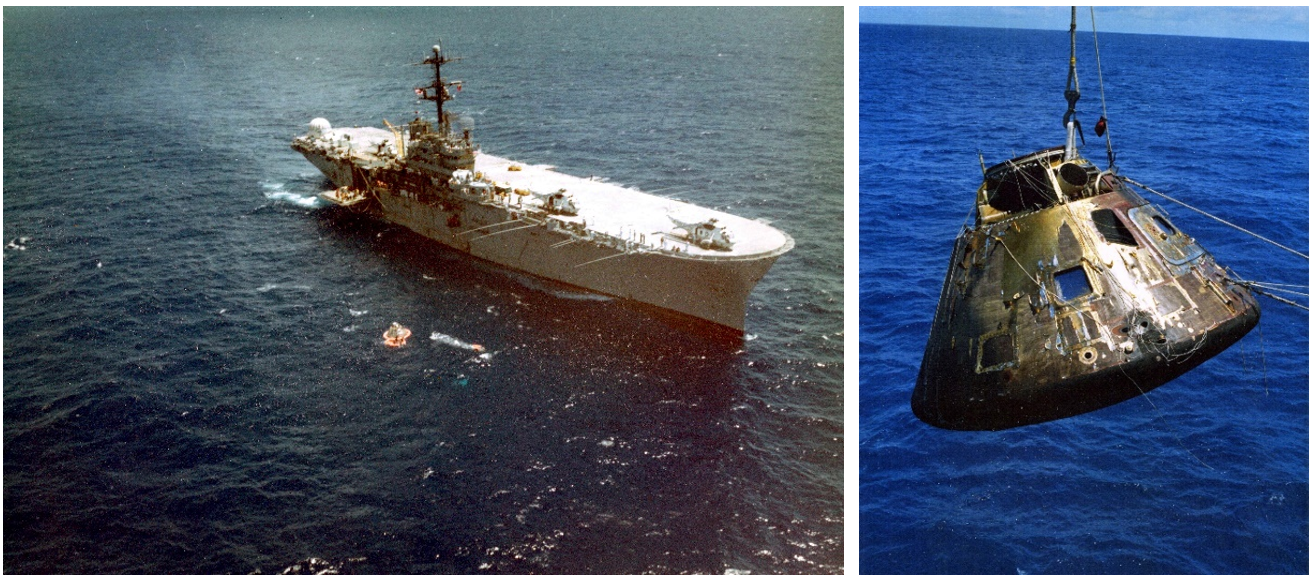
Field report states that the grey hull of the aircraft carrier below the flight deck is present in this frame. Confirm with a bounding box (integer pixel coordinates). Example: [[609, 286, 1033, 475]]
[[294, 150, 792, 334]]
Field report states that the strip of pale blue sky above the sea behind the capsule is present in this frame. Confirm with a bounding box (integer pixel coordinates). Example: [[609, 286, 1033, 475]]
[[860, 7, 1309, 42]]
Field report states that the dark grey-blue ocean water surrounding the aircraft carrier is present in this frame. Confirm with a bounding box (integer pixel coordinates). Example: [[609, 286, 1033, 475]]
[[3, 8, 840, 573]]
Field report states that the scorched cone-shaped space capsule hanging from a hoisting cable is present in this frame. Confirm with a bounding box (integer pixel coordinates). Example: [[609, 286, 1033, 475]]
[[911, 8, 1259, 430]]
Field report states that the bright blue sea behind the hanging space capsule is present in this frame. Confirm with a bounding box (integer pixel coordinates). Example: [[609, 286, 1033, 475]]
[[850, 21, 1309, 574]]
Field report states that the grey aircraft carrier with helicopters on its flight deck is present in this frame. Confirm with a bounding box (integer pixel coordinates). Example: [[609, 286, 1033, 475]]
[[291, 46, 793, 335]]
